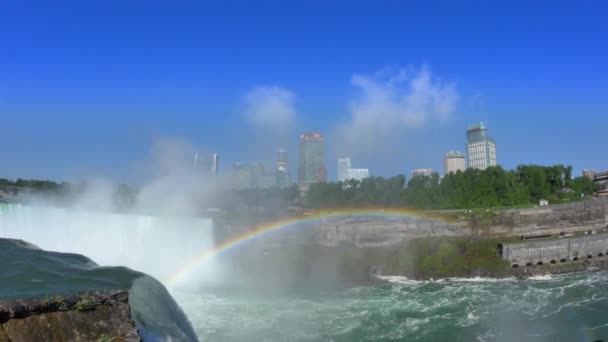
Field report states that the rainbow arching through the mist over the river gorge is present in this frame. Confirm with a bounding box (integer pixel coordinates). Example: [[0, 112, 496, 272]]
[[167, 208, 448, 286]]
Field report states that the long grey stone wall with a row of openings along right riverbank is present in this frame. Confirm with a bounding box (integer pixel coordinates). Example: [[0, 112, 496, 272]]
[[502, 233, 608, 267]]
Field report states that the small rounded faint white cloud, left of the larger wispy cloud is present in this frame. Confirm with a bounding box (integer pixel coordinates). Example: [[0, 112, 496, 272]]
[[245, 86, 296, 133]]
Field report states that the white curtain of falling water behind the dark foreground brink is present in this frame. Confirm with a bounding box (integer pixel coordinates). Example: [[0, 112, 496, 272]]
[[0, 204, 213, 284]]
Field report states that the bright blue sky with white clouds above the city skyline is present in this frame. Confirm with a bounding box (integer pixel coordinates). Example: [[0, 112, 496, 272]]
[[0, 1, 608, 181]]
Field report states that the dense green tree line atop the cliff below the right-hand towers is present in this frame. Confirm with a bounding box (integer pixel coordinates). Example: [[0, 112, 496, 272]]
[[305, 165, 598, 209]]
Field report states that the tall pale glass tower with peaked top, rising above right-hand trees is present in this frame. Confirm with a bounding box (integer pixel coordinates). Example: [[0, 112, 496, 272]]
[[467, 122, 496, 170]]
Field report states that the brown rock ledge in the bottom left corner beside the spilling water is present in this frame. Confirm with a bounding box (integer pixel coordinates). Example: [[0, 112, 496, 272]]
[[0, 291, 141, 342]]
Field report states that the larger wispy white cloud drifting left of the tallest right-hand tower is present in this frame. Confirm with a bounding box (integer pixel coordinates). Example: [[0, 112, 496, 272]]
[[336, 66, 459, 156]]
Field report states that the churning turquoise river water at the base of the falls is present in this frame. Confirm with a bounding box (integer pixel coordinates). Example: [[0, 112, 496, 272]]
[[174, 272, 608, 342]]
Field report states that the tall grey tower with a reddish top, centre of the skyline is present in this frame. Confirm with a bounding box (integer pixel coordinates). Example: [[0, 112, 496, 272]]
[[298, 133, 327, 189]]
